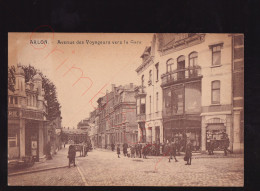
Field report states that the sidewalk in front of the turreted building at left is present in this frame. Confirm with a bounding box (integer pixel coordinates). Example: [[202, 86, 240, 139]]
[[8, 145, 69, 176]]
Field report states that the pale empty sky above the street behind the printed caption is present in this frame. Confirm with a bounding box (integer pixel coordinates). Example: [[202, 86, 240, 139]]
[[8, 33, 153, 127]]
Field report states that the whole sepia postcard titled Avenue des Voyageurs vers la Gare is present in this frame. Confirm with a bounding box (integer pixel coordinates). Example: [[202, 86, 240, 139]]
[[7, 32, 244, 187]]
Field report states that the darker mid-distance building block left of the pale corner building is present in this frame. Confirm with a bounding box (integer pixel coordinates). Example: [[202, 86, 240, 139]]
[[96, 83, 138, 148]]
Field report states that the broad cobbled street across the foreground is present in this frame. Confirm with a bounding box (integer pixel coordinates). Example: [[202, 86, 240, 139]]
[[8, 148, 244, 187]]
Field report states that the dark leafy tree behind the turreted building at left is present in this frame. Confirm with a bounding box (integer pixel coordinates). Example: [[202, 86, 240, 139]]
[[22, 65, 61, 121]]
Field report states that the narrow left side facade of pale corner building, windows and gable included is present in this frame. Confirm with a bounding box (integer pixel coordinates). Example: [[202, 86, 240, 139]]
[[135, 35, 163, 143]]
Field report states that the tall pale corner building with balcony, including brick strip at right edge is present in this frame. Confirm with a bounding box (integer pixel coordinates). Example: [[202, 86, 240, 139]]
[[136, 33, 244, 152]]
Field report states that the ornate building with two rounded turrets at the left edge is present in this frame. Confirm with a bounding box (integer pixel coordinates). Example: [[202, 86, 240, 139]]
[[8, 64, 48, 161]]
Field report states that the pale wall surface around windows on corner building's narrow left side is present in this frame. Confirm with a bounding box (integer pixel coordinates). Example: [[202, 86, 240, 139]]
[[137, 35, 163, 143]]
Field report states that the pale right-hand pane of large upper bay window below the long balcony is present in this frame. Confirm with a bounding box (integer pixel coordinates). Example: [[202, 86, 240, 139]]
[[185, 82, 201, 113]]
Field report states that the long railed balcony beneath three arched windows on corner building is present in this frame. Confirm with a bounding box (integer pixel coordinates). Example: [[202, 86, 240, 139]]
[[161, 66, 202, 87]]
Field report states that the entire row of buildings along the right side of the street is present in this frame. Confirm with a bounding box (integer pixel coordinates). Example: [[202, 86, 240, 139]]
[[83, 33, 244, 152]]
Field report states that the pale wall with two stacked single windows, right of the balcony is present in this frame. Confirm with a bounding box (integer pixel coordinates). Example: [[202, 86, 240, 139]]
[[199, 34, 233, 151]]
